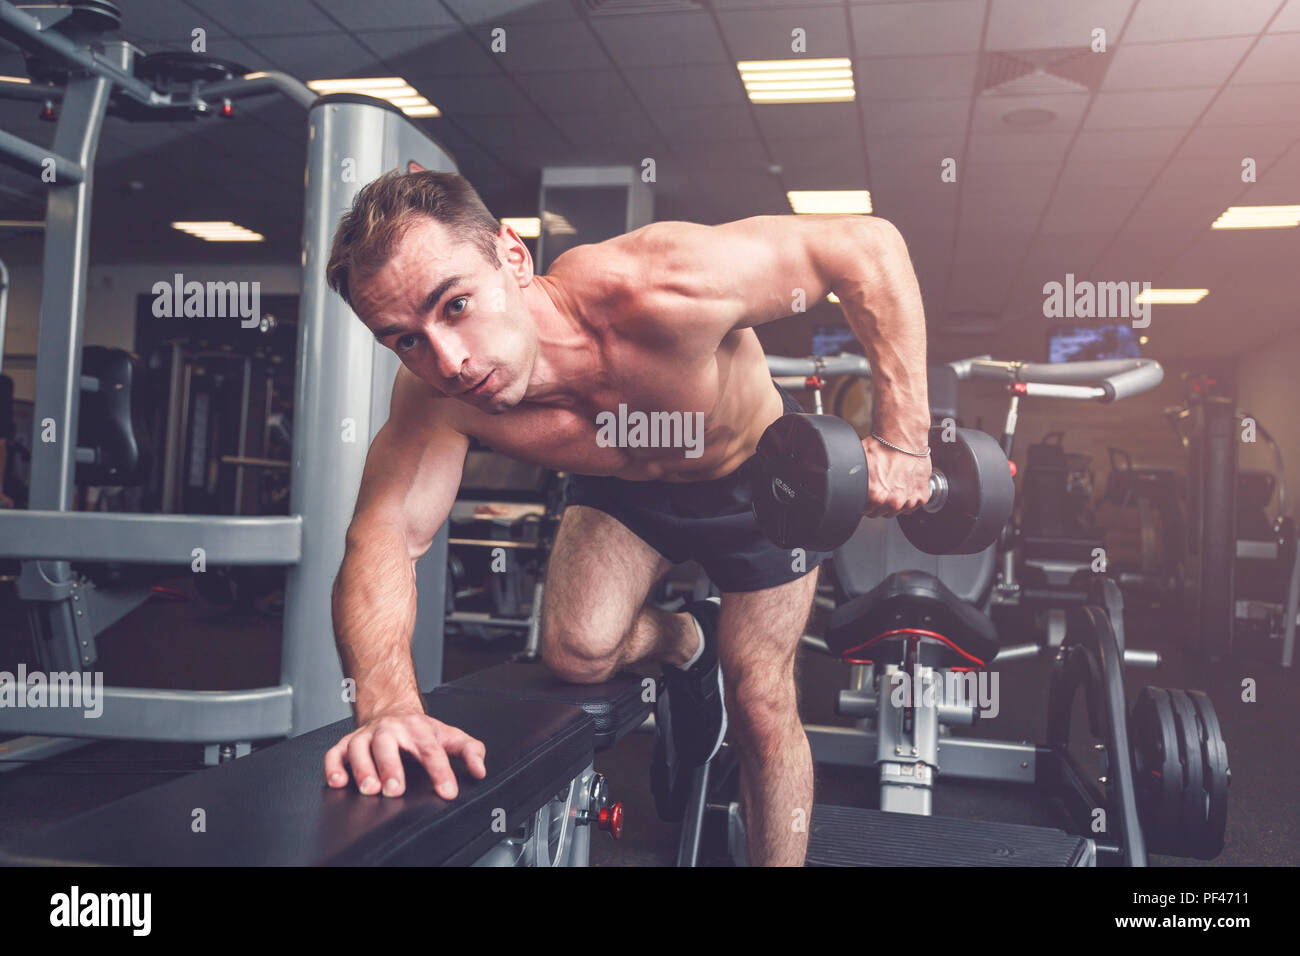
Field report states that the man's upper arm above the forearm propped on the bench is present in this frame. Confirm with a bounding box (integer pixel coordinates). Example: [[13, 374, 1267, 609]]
[[352, 372, 469, 559]]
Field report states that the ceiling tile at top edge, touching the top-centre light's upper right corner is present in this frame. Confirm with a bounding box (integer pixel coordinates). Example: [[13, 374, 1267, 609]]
[[849, 0, 984, 56]]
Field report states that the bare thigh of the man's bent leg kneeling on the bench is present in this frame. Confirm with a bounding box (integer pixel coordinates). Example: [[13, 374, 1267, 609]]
[[542, 505, 672, 650]]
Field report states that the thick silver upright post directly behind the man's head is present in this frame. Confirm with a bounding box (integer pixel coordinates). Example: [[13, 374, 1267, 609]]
[[281, 94, 455, 734]]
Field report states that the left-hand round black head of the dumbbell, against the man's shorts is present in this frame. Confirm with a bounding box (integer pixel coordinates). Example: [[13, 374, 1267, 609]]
[[753, 414, 867, 551]]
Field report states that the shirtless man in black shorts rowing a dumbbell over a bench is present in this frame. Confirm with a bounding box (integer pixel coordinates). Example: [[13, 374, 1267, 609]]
[[325, 172, 931, 865]]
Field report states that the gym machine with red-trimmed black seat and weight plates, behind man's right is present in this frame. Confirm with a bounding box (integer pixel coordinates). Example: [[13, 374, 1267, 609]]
[[679, 356, 1230, 866]]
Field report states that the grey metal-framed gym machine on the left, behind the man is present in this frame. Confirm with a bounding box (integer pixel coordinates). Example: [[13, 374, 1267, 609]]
[[0, 0, 454, 769]]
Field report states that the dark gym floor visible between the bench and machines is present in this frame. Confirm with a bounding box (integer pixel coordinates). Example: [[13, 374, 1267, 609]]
[[0, 578, 1300, 866]]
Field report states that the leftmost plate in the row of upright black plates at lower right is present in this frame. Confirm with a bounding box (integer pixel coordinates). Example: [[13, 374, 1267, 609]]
[[1128, 687, 1183, 853]]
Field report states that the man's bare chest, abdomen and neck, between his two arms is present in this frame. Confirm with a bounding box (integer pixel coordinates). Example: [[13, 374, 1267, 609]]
[[445, 238, 783, 481]]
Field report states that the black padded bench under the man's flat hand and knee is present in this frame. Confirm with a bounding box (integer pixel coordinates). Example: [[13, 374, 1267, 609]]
[[0, 663, 650, 866]]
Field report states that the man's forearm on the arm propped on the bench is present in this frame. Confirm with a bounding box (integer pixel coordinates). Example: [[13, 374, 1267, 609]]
[[333, 522, 424, 722]]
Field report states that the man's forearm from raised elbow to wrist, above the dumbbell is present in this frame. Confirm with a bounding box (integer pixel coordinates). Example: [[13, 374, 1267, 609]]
[[833, 220, 930, 450]]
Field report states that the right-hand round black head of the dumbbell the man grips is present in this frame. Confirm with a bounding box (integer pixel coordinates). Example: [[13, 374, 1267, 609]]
[[898, 425, 1015, 554]]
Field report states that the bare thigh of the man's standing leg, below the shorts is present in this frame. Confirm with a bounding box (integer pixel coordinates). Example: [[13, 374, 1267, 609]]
[[718, 568, 818, 705]]
